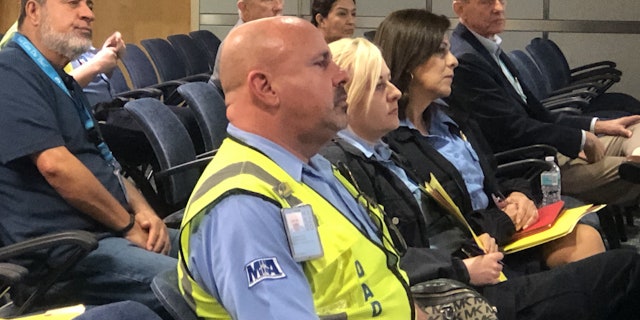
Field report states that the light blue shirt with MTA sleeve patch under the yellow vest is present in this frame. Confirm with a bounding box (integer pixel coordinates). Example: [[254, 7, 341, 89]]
[[188, 125, 380, 319]]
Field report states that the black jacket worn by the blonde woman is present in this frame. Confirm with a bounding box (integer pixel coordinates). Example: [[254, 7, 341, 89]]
[[320, 138, 471, 285]]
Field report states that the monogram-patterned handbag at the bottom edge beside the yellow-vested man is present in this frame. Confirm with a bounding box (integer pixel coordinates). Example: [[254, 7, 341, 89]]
[[411, 279, 498, 320]]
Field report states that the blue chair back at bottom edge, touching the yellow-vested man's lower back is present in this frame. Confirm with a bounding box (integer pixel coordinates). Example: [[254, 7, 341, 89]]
[[151, 268, 198, 320]]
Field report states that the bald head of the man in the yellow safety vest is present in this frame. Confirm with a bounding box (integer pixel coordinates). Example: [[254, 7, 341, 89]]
[[220, 17, 348, 161]]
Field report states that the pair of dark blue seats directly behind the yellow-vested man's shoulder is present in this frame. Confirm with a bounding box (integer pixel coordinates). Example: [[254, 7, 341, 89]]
[[125, 82, 229, 217]]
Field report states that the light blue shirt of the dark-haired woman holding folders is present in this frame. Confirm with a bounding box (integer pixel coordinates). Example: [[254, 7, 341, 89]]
[[400, 104, 489, 210]]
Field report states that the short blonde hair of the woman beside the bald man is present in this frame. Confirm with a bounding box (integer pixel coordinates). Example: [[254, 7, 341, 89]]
[[329, 38, 384, 115]]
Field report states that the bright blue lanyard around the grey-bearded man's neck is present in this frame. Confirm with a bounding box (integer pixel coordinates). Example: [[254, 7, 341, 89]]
[[13, 32, 120, 168]]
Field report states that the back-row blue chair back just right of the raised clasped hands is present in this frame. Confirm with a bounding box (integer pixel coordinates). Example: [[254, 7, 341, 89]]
[[122, 43, 158, 89]]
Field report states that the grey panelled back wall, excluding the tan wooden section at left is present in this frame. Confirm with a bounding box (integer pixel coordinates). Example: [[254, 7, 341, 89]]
[[193, 0, 640, 98]]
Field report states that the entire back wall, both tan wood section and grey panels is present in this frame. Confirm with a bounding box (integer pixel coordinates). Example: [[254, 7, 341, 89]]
[[0, 0, 640, 97]]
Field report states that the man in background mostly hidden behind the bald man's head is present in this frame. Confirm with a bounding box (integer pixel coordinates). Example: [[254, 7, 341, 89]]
[[209, 0, 284, 92]]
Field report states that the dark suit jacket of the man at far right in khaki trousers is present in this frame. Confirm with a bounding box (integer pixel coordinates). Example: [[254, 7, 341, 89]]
[[449, 23, 592, 157]]
